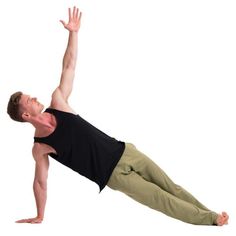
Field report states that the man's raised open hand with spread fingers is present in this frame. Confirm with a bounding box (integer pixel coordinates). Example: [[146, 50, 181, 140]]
[[60, 7, 82, 32]]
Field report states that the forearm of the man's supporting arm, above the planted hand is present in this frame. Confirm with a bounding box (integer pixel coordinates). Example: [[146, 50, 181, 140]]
[[33, 180, 47, 219]]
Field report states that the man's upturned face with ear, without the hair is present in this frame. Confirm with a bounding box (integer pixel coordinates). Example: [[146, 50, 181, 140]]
[[19, 94, 44, 119]]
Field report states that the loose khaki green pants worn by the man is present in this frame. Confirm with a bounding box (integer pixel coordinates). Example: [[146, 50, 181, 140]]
[[107, 143, 217, 225]]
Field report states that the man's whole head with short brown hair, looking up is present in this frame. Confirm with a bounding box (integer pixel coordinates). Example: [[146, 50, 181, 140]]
[[7, 92, 44, 122]]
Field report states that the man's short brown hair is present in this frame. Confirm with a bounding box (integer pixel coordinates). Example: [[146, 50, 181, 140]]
[[7, 92, 26, 122]]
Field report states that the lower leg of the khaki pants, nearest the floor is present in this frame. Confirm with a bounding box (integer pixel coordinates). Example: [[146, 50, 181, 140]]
[[108, 171, 217, 225]]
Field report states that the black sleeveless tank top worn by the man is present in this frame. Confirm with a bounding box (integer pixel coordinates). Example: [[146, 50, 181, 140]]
[[34, 108, 125, 192]]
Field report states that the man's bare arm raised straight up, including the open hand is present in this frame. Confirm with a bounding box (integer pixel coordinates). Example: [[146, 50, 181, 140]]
[[52, 7, 82, 106]]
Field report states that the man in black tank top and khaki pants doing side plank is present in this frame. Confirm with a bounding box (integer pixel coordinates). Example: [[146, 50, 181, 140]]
[[8, 7, 228, 225]]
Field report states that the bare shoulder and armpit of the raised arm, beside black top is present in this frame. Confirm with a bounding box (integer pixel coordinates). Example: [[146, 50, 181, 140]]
[[50, 88, 76, 114]]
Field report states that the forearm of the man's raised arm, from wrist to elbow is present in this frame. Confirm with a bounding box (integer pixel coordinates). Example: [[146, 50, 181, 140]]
[[63, 31, 78, 70]]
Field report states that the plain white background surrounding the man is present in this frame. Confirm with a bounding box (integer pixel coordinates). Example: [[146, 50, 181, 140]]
[[0, 0, 236, 236]]
